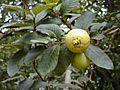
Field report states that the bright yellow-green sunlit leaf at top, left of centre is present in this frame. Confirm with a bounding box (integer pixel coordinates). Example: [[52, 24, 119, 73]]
[[32, 3, 56, 16]]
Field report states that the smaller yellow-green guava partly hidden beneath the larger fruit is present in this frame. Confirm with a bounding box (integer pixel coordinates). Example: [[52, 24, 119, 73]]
[[72, 53, 90, 70]]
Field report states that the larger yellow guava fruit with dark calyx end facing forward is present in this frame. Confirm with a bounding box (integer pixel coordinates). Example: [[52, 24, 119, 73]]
[[65, 29, 90, 53]]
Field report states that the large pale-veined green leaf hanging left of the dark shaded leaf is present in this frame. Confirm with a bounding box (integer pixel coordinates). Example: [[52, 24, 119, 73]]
[[38, 45, 60, 76]]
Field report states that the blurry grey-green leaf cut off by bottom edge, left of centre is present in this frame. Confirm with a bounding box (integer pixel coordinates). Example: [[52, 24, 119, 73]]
[[19, 78, 34, 90]]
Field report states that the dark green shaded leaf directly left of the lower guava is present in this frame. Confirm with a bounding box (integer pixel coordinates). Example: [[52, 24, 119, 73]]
[[53, 45, 73, 76]]
